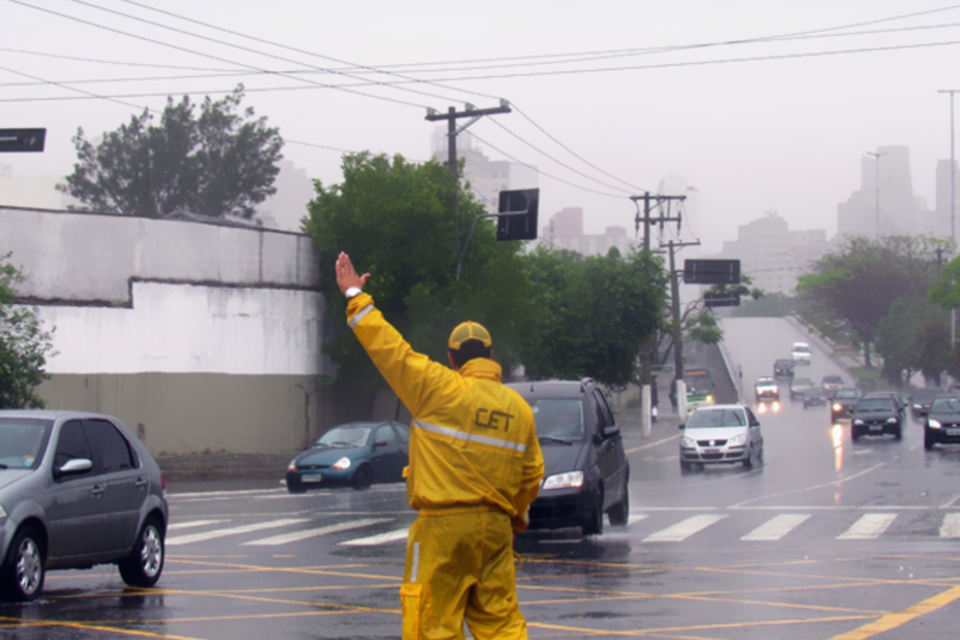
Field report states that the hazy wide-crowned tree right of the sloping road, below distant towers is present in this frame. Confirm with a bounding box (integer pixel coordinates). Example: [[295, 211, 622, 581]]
[[797, 236, 940, 367]]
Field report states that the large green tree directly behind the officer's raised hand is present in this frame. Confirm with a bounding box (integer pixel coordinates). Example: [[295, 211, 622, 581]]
[[305, 153, 532, 389]]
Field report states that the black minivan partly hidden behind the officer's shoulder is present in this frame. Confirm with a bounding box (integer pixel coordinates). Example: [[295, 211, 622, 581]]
[[508, 378, 630, 535]]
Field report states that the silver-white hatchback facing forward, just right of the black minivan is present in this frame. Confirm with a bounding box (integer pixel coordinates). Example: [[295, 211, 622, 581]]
[[680, 404, 763, 472]]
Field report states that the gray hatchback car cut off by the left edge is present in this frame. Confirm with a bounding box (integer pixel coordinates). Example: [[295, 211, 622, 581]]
[[0, 410, 168, 600]]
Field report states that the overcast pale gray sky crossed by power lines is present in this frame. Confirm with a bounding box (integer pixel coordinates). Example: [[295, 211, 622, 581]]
[[0, 0, 960, 249]]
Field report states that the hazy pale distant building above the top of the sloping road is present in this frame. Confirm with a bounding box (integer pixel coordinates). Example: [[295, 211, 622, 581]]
[[711, 212, 831, 296]]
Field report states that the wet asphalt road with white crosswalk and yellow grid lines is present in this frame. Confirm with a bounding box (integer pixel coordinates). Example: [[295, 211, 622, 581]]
[[0, 319, 960, 640]]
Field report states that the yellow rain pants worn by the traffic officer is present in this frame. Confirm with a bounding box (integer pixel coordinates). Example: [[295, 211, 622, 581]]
[[400, 505, 527, 640]]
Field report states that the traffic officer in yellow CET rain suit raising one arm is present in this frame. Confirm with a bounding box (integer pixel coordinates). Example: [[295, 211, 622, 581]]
[[336, 252, 543, 640]]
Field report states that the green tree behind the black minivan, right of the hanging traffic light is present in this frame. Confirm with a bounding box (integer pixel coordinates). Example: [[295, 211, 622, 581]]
[[521, 247, 667, 388]]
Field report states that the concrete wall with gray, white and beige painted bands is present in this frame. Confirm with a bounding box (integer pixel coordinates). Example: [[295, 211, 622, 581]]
[[0, 207, 334, 453]]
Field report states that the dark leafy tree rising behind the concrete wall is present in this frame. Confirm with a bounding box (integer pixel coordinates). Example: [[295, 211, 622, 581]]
[[57, 85, 283, 218]]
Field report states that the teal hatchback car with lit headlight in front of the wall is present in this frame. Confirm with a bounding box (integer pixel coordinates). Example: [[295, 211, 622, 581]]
[[287, 420, 410, 493]]
